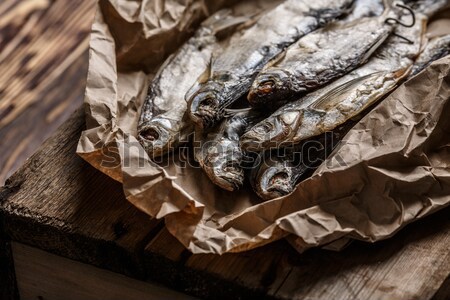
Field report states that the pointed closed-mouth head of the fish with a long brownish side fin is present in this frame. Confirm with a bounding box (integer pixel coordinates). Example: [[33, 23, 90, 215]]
[[240, 110, 302, 151]]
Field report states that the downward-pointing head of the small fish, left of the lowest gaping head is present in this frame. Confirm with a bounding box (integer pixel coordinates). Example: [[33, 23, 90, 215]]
[[201, 141, 244, 191]]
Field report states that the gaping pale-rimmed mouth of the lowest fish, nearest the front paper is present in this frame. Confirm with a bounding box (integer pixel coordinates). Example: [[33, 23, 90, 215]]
[[258, 167, 294, 200]]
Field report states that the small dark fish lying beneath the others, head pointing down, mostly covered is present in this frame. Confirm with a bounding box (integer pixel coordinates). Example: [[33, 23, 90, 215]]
[[194, 110, 263, 191]]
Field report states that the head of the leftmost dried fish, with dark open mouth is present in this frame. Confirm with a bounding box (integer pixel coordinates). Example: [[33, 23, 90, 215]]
[[138, 117, 179, 158]]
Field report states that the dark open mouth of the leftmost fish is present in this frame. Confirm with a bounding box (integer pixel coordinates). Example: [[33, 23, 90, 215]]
[[138, 123, 172, 158]]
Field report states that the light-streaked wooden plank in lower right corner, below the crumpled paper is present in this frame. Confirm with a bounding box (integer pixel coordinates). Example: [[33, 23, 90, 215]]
[[276, 208, 450, 299]]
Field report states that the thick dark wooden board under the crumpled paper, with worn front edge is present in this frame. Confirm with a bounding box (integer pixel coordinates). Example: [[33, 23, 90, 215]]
[[0, 110, 450, 299]]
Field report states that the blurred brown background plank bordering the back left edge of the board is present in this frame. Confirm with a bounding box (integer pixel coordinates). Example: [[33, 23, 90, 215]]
[[0, 52, 88, 184]]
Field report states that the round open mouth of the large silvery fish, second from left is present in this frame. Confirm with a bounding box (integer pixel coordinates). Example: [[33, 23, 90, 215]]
[[188, 92, 220, 128]]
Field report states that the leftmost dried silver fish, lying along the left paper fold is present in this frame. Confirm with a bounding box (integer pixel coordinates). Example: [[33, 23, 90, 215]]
[[138, 10, 248, 157]]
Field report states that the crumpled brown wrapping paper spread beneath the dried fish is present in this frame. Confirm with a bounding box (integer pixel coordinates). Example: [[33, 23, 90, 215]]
[[77, 0, 450, 253]]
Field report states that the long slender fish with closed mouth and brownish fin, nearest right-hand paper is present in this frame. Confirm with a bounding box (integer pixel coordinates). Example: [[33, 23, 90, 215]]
[[240, 15, 426, 151]]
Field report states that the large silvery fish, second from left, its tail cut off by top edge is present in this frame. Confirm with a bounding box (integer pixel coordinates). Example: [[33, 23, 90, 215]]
[[188, 0, 353, 128]]
